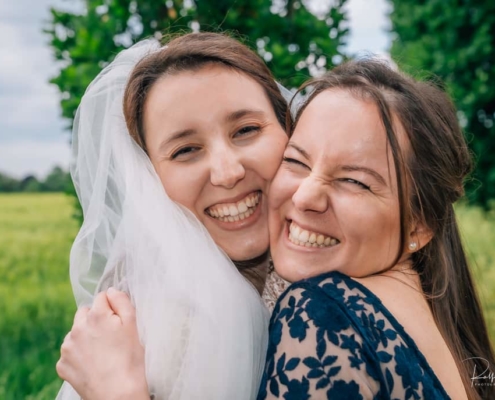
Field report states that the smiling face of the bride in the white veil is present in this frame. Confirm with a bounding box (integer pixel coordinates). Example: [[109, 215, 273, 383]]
[[144, 64, 287, 261]]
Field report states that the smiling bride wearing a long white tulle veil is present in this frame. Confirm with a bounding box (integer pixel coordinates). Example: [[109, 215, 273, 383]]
[[57, 33, 287, 400]]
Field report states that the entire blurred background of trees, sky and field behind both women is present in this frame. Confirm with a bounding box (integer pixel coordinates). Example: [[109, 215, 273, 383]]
[[0, 0, 495, 400]]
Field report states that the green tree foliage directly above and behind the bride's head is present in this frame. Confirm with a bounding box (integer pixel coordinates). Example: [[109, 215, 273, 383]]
[[46, 0, 347, 125]]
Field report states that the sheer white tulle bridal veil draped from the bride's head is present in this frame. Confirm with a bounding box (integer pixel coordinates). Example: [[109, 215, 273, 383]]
[[57, 40, 269, 400]]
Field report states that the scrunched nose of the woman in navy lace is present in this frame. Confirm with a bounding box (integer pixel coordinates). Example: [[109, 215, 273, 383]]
[[292, 175, 328, 213]]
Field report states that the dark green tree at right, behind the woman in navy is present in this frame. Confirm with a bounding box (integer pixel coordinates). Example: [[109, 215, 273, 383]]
[[391, 0, 495, 206]]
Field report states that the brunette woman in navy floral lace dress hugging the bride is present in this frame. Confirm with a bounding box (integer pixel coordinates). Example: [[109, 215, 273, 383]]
[[258, 60, 495, 400]]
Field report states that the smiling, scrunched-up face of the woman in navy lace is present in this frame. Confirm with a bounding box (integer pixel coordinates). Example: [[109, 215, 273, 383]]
[[269, 89, 400, 281]]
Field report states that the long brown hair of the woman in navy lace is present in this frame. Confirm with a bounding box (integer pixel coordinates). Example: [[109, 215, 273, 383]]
[[294, 60, 495, 399]]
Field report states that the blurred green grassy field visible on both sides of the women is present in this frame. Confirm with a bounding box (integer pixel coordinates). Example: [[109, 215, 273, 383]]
[[0, 194, 495, 400]]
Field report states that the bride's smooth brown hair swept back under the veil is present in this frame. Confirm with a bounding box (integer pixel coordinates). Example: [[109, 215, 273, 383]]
[[124, 32, 287, 150]]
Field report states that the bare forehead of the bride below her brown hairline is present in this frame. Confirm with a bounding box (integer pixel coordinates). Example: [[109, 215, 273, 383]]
[[144, 64, 271, 120]]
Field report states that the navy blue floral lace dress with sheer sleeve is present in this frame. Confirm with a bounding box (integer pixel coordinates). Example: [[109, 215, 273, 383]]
[[258, 272, 450, 400]]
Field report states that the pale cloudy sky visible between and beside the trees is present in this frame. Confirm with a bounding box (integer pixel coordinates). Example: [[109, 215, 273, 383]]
[[0, 0, 390, 178]]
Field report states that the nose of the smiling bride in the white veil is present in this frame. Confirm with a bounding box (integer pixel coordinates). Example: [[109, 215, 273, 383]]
[[210, 148, 246, 189]]
